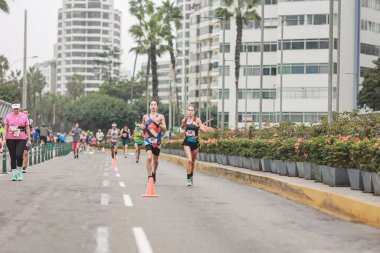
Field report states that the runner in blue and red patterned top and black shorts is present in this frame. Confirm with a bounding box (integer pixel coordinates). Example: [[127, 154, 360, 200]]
[[140, 100, 166, 183]]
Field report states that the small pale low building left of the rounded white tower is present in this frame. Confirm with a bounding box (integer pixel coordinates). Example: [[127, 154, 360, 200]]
[[35, 60, 57, 94]]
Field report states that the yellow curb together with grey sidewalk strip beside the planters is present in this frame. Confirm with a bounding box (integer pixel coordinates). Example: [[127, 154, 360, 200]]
[[162, 154, 380, 228]]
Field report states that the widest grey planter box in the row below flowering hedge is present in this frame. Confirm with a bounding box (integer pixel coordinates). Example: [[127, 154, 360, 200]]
[[321, 166, 350, 186]]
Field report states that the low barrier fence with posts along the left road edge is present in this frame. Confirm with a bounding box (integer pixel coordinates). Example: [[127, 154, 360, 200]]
[[2, 143, 71, 174]]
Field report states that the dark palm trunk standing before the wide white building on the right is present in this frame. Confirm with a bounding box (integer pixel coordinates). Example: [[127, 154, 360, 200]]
[[235, 12, 243, 129]]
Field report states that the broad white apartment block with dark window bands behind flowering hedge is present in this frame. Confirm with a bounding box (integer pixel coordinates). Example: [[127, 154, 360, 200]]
[[185, 0, 380, 128]]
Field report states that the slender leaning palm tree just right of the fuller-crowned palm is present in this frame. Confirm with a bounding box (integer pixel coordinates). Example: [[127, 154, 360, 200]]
[[158, 0, 183, 125]]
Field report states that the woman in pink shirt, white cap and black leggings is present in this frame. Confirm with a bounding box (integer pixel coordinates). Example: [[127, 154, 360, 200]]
[[4, 102, 31, 181]]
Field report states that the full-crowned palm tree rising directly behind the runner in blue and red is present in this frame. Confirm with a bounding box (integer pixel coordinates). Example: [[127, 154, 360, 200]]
[[129, 0, 168, 100]]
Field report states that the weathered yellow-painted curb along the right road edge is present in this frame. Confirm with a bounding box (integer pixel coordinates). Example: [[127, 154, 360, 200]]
[[160, 153, 380, 228]]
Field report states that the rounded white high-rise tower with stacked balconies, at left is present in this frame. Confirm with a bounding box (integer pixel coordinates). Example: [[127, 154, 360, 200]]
[[57, 0, 121, 93]]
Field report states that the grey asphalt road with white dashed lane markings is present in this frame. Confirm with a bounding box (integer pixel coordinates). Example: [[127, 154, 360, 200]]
[[0, 152, 380, 253]]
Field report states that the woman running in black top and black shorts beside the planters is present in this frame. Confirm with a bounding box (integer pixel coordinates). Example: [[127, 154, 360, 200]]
[[181, 105, 207, 186]]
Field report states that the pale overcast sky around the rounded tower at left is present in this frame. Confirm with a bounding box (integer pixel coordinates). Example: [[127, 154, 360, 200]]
[[0, 0, 161, 74]]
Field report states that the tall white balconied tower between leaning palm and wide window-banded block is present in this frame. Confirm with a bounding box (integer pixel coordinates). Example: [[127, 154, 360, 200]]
[[181, 0, 220, 120]]
